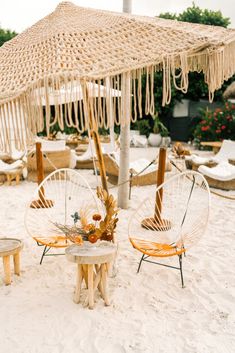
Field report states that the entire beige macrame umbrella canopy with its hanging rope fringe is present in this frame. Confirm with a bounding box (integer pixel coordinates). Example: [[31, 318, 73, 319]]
[[0, 2, 235, 150]]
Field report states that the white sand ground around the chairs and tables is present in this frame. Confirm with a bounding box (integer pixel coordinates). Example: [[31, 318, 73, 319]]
[[0, 149, 235, 353]]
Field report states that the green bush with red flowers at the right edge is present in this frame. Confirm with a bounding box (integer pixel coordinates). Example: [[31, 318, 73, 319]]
[[193, 102, 235, 142]]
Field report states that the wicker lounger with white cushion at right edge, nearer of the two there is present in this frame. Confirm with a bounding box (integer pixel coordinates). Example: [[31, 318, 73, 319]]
[[198, 161, 235, 190]]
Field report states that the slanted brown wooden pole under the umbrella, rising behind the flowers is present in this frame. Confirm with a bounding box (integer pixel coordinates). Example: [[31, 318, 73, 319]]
[[81, 82, 109, 193]]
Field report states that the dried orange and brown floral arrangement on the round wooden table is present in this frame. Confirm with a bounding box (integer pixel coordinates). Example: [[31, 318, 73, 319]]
[[54, 187, 118, 245]]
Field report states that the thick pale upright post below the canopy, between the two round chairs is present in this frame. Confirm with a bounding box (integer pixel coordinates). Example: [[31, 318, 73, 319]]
[[118, 73, 131, 209]]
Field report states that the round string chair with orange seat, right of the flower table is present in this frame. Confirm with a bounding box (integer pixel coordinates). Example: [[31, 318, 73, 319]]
[[128, 171, 210, 287]]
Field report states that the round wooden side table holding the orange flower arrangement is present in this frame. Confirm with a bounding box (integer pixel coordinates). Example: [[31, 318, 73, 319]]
[[65, 242, 117, 309]]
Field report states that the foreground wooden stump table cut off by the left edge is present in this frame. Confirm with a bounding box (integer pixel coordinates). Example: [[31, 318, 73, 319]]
[[0, 238, 23, 285]]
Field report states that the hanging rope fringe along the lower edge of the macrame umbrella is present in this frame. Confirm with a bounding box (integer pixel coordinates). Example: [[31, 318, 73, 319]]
[[0, 42, 235, 153]]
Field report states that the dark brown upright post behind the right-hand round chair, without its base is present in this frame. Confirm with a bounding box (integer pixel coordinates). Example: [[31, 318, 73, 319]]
[[154, 147, 166, 222]]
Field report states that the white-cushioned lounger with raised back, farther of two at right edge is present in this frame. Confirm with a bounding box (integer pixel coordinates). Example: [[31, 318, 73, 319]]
[[185, 140, 235, 170]]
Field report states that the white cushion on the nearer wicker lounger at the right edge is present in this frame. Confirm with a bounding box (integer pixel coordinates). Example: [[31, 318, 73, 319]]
[[198, 162, 235, 181]]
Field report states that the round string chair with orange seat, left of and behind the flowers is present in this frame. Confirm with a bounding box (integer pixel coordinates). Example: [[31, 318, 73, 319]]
[[25, 168, 101, 264]]
